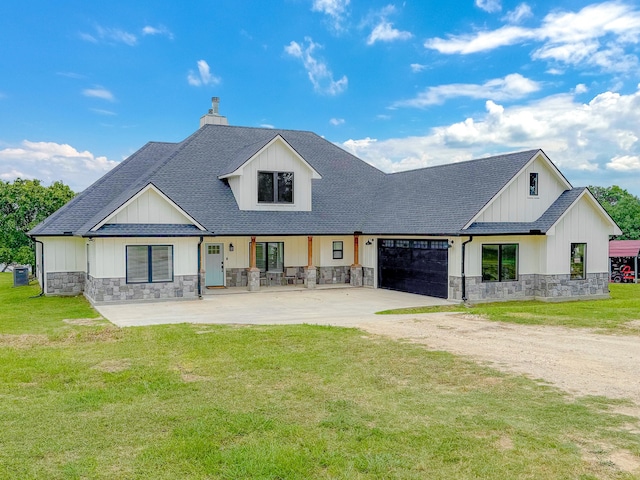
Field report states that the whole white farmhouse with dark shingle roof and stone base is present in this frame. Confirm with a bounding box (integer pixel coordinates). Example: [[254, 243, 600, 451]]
[[30, 98, 621, 302]]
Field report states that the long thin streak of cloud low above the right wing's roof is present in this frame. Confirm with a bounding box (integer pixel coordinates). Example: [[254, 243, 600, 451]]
[[392, 73, 540, 108]]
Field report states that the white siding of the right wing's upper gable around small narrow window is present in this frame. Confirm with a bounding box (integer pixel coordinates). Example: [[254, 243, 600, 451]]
[[473, 155, 571, 226]]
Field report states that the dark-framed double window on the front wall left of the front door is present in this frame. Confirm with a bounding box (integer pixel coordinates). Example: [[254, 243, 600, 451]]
[[126, 245, 173, 283]]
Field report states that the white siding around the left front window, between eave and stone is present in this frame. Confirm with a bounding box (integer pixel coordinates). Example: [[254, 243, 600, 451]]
[[90, 237, 200, 278]]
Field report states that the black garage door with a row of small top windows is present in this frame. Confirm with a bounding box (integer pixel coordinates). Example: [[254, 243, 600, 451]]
[[378, 239, 449, 298]]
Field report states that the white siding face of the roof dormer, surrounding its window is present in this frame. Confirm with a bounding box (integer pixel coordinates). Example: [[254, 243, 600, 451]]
[[228, 139, 317, 212]]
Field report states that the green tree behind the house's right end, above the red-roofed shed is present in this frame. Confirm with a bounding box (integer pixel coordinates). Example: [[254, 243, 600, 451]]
[[589, 185, 640, 240]]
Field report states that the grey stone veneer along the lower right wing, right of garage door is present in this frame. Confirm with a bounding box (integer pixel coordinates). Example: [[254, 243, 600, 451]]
[[449, 273, 609, 302]]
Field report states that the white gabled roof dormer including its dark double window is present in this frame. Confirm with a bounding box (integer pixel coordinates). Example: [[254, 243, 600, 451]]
[[218, 134, 322, 212]]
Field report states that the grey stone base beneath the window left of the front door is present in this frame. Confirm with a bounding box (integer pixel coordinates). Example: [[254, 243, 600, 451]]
[[84, 275, 198, 302]]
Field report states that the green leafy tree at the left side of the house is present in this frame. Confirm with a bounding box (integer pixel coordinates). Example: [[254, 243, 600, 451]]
[[0, 178, 75, 265]]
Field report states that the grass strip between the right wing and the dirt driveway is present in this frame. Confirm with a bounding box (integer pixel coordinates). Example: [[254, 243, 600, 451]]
[[379, 283, 640, 333]]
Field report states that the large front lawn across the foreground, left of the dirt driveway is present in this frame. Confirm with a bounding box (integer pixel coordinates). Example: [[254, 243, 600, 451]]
[[0, 275, 640, 480]]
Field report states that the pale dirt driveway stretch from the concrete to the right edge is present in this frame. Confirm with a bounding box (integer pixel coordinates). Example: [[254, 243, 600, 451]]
[[358, 312, 640, 417]]
